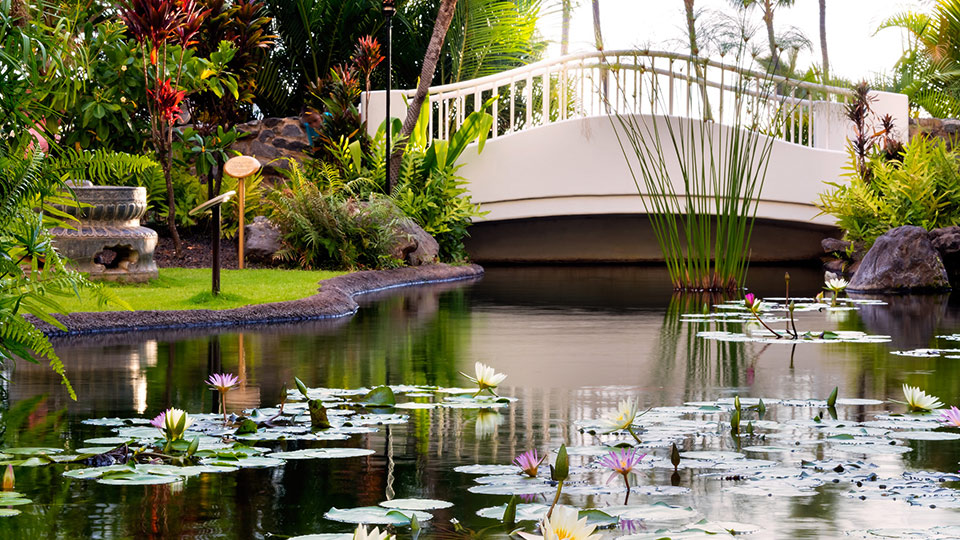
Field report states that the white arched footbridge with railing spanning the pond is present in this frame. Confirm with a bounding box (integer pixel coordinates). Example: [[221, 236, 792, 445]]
[[365, 50, 908, 262]]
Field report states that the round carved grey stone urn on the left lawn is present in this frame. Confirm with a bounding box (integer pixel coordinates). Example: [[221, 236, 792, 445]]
[[51, 182, 157, 283]]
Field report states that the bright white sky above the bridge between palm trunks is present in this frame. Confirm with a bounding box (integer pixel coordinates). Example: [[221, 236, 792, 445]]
[[541, 0, 930, 80]]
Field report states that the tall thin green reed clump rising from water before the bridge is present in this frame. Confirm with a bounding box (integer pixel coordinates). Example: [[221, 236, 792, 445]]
[[611, 56, 793, 291]]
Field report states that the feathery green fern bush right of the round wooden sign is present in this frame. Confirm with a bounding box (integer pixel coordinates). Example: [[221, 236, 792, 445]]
[[269, 161, 403, 268]]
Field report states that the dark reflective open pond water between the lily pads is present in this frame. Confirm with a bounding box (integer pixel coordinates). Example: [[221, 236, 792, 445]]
[[0, 267, 960, 538]]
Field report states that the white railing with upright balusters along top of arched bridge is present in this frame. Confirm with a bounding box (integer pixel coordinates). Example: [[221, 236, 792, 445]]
[[364, 49, 907, 150]]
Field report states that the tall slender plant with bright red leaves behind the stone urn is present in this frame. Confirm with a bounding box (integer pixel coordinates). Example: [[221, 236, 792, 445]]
[[119, 0, 209, 255]]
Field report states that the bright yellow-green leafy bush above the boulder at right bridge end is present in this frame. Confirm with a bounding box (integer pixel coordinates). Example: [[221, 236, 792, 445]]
[[817, 136, 960, 248]]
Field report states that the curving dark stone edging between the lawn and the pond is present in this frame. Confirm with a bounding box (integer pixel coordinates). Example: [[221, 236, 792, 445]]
[[33, 264, 483, 337]]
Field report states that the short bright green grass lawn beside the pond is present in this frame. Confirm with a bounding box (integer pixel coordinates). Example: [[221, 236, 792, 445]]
[[60, 268, 345, 312]]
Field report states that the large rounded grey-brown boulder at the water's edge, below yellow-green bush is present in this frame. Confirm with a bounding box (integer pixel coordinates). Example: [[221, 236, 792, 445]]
[[847, 225, 950, 293]]
